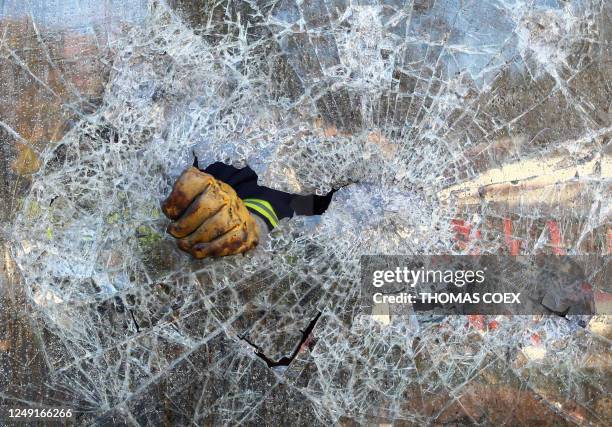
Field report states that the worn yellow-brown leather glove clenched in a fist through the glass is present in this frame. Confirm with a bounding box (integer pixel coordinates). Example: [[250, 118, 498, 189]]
[[162, 167, 259, 259]]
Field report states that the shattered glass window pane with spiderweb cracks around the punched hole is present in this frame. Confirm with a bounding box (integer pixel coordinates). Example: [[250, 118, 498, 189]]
[[0, 0, 612, 426]]
